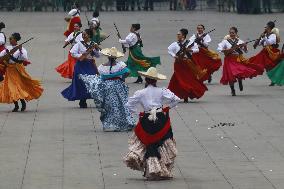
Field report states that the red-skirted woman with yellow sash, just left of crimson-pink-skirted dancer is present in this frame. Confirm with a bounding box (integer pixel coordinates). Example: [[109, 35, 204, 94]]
[[190, 24, 222, 83]]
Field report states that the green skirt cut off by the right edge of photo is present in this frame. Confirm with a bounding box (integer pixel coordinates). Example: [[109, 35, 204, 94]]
[[267, 60, 284, 86]]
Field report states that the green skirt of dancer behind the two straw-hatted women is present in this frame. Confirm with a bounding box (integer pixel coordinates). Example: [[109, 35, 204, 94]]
[[126, 45, 161, 77]]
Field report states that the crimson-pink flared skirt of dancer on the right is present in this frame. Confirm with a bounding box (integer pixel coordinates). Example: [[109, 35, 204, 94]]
[[220, 55, 258, 85]]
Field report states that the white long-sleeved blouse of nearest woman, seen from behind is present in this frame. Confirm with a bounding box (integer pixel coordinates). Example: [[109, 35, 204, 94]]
[[126, 85, 180, 113]]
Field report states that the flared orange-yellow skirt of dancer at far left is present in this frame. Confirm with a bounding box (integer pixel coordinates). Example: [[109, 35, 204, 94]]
[[0, 64, 43, 103]]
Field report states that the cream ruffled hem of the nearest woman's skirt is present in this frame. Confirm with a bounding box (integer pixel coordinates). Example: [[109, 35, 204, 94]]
[[123, 134, 177, 180]]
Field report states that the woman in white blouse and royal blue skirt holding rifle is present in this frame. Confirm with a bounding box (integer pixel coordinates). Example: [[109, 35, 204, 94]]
[[61, 29, 99, 108]]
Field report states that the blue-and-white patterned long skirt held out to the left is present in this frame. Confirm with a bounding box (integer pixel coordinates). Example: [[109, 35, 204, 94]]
[[80, 75, 135, 131]]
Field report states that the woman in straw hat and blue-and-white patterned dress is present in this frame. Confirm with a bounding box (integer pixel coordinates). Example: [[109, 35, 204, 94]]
[[80, 47, 135, 131]]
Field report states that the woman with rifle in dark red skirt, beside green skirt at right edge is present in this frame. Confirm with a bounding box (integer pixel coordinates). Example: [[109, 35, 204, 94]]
[[249, 21, 280, 86]]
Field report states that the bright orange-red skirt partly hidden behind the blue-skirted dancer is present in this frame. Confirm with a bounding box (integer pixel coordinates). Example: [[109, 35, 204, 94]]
[[55, 52, 76, 79]]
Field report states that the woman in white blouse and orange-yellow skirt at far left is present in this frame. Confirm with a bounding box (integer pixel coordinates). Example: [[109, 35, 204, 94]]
[[0, 33, 43, 112]]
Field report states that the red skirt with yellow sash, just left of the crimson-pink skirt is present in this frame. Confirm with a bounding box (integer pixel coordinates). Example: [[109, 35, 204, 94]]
[[192, 47, 222, 81]]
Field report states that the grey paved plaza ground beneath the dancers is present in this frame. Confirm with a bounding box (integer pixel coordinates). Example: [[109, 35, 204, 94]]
[[0, 11, 284, 189]]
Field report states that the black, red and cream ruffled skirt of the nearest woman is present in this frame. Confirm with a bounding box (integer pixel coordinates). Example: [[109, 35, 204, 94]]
[[123, 108, 177, 180]]
